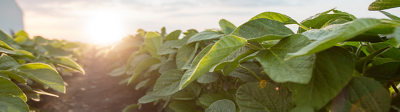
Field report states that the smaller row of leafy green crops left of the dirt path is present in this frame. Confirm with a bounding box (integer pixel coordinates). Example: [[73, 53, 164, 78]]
[[0, 30, 85, 112]]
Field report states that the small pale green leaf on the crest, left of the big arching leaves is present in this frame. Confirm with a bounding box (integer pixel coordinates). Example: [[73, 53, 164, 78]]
[[186, 31, 222, 44]]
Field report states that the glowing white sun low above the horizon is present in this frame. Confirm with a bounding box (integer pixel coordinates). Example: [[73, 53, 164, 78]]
[[85, 9, 126, 44]]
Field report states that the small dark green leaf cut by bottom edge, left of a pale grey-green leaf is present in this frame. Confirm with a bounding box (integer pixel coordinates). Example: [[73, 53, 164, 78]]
[[169, 100, 196, 112]]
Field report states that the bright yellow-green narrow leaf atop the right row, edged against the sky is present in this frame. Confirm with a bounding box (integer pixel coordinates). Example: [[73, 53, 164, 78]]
[[250, 12, 298, 24]]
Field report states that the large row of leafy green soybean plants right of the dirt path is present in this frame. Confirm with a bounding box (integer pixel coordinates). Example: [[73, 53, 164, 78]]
[[104, 0, 400, 112]]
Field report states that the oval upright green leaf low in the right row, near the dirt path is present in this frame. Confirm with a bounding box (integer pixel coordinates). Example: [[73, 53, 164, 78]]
[[153, 69, 184, 96]]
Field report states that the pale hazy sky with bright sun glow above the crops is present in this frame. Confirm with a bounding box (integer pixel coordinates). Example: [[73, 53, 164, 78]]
[[12, 0, 400, 43]]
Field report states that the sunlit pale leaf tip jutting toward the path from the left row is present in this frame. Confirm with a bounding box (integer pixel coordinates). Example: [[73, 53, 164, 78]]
[[52, 57, 85, 74]]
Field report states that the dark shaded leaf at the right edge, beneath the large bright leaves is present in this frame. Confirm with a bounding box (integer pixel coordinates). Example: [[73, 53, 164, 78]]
[[365, 62, 400, 81]]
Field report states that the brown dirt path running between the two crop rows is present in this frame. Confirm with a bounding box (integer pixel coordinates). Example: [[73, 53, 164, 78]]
[[28, 53, 149, 112]]
